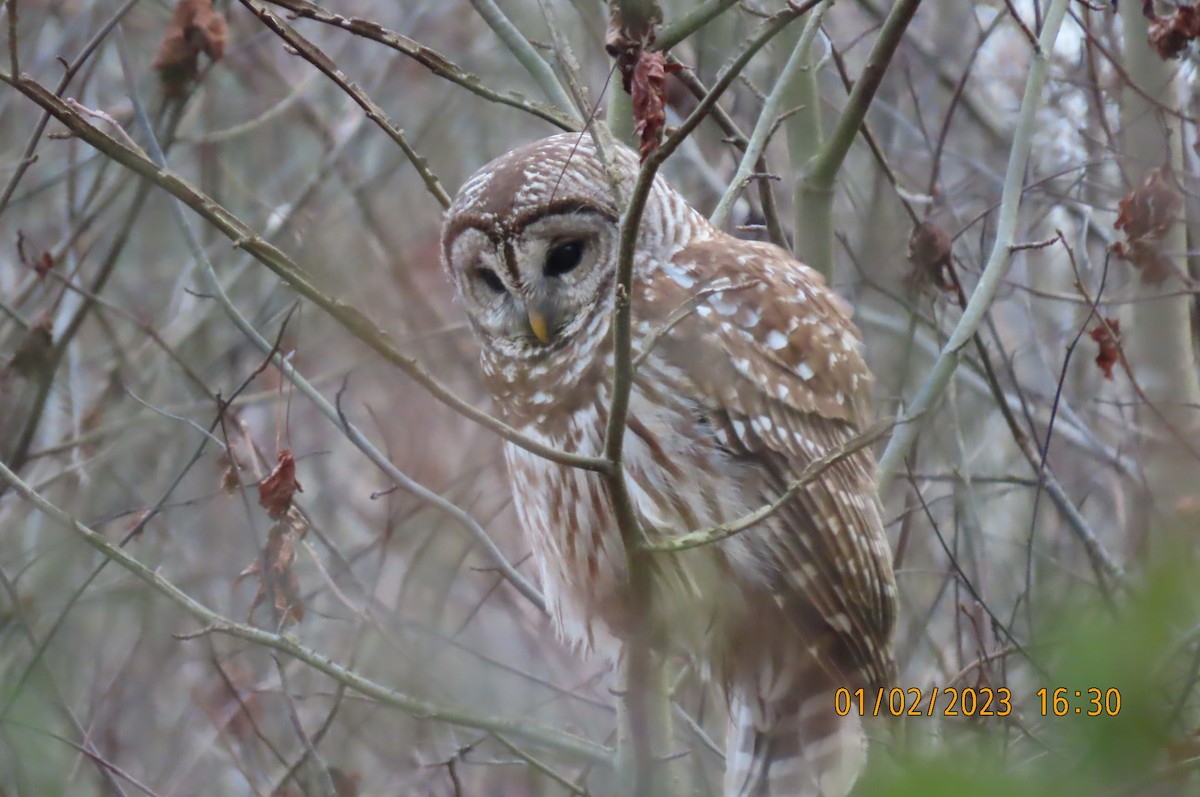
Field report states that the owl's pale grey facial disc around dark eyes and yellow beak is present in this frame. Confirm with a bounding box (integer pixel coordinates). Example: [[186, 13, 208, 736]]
[[449, 211, 617, 356]]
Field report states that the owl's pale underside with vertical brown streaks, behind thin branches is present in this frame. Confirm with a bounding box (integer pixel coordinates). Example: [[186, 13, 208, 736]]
[[505, 368, 748, 659]]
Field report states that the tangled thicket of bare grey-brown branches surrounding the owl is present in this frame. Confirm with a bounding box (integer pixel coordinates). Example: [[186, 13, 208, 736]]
[[0, 0, 1200, 796]]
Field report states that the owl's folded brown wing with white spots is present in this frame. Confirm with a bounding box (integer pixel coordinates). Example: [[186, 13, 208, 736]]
[[653, 236, 896, 685]]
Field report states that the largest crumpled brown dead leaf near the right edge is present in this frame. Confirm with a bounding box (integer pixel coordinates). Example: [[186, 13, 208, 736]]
[[1112, 167, 1183, 283]]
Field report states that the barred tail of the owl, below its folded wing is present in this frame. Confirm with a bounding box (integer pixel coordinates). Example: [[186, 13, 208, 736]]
[[725, 688, 866, 797]]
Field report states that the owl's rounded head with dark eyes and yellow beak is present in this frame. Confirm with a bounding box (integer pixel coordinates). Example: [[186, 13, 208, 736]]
[[442, 133, 686, 360]]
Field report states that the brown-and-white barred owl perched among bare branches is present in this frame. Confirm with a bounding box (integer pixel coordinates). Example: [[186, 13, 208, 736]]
[[442, 133, 895, 797]]
